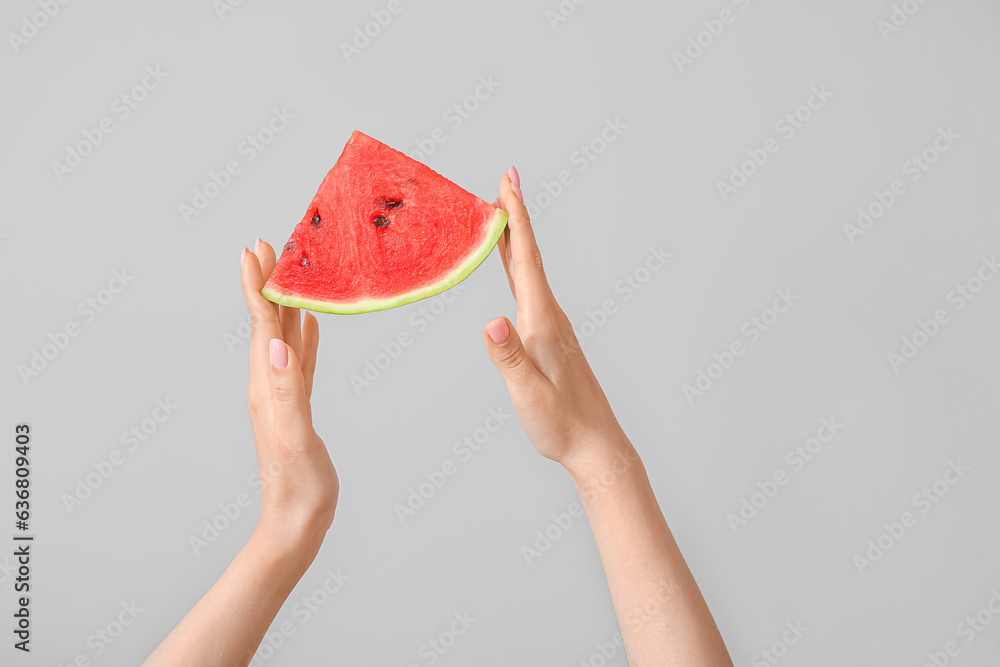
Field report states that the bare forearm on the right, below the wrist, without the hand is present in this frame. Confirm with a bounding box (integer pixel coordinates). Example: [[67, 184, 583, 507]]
[[566, 432, 732, 667]]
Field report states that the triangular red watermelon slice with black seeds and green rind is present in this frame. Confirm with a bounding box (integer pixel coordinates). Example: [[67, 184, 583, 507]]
[[261, 132, 507, 315]]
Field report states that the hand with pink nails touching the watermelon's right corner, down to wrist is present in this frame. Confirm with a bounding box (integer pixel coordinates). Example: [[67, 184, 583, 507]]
[[483, 167, 623, 468]]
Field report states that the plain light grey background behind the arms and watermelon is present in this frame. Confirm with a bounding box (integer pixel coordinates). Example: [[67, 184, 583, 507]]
[[0, 0, 1000, 667]]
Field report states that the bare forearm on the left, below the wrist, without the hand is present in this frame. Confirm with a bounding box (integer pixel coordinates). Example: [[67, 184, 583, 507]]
[[143, 530, 319, 667]]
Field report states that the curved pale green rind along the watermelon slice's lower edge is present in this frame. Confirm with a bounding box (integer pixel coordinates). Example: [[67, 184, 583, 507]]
[[260, 209, 507, 315]]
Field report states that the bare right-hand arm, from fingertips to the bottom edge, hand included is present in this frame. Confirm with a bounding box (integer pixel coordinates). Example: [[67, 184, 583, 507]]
[[484, 167, 732, 667]]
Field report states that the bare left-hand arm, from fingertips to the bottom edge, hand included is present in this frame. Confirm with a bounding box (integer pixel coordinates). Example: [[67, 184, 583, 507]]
[[143, 242, 339, 667]]
